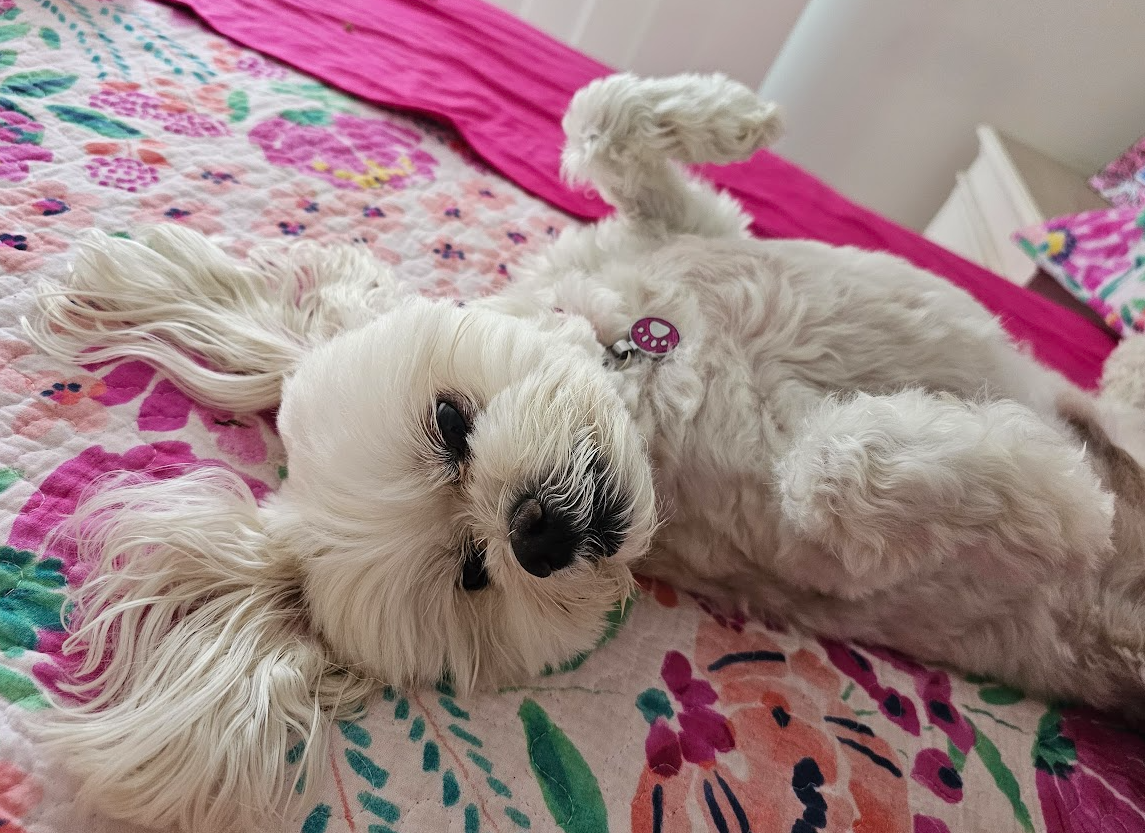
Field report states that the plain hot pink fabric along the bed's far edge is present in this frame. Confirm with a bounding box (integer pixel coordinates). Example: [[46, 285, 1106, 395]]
[[161, 0, 1113, 387]]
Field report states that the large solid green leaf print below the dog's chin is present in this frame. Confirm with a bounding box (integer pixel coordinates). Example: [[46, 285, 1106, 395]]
[[518, 698, 608, 833]]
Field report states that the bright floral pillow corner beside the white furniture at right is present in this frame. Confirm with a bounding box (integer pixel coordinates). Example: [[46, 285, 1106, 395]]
[[1014, 206, 1145, 335]]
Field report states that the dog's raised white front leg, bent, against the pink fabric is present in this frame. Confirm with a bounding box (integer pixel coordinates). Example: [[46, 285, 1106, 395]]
[[561, 73, 782, 237]]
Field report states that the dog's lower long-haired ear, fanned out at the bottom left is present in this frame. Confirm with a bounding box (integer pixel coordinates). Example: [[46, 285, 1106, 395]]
[[37, 469, 373, 832]]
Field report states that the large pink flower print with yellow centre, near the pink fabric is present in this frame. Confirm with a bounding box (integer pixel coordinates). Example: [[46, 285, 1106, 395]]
[[250, 113, 437, 190]]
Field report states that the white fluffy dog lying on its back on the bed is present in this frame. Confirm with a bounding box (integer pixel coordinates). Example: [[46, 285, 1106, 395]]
[[30, 74, 1145, 831]]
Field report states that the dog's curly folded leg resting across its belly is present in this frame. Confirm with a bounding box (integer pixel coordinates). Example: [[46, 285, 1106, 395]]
[[776, 390, 1113, 598]]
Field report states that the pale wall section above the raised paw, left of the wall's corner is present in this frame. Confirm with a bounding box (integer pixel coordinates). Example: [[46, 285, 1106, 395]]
[[492, 0, 806, 87]]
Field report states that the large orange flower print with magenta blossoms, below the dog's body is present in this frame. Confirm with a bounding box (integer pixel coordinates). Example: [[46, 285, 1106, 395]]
[[631, 619, 910, 833]]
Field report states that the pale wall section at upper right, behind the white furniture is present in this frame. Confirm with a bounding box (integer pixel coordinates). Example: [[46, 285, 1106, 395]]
[[760, 0, 1145, 228]]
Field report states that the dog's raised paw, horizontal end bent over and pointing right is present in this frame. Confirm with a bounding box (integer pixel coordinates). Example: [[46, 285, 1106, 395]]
[[562, 73, 782, 181]]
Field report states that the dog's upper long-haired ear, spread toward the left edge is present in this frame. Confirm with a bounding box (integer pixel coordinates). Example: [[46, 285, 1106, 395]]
[[23, 225, 405, 412]]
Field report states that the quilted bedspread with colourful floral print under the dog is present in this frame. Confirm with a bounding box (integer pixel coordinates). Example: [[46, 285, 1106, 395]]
[[0, 0, 1145, 833]]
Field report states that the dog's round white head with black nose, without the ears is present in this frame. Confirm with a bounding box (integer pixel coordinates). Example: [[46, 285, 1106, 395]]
[[268, 299, 655, 689]]
